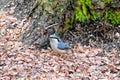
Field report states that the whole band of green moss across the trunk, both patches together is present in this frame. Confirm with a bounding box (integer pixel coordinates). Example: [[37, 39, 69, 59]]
[[71, 0, 120, 25]]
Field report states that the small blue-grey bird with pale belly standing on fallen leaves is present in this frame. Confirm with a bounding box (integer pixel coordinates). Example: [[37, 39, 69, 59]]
[[50, 34, 70, 53]]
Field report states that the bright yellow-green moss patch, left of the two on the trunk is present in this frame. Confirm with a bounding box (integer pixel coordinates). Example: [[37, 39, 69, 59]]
[[74, 0, 100, 23]]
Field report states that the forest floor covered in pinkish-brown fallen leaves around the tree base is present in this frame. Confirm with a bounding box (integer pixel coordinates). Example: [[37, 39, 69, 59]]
[[0, 0, 120, 80]]
